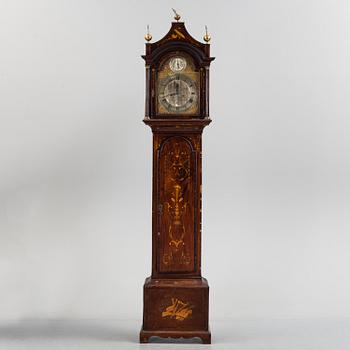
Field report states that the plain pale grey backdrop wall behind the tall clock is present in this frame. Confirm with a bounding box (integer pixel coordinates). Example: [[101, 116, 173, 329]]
[[0, 0, 350, 324]]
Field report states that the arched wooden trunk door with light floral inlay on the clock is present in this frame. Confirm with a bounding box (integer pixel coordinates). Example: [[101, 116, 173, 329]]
[[157, 136, 197, 273]]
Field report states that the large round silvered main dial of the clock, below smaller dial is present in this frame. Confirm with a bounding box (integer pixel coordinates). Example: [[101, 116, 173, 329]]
[[158, 74, 197, 112]]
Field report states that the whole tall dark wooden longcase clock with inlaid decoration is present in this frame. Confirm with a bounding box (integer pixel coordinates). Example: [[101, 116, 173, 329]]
[[140, 13, 214, 343]]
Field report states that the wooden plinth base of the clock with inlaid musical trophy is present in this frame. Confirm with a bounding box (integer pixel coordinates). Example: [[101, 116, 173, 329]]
[[140, 277, 211, 344]]
